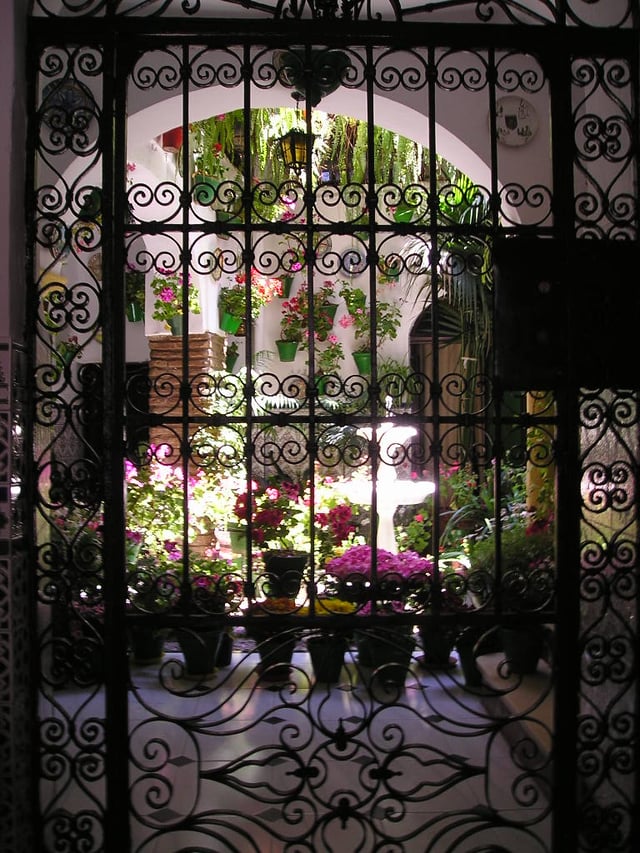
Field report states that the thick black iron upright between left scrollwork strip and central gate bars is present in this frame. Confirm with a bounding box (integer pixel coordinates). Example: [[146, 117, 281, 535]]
[[101, 29, 130, 853]]
